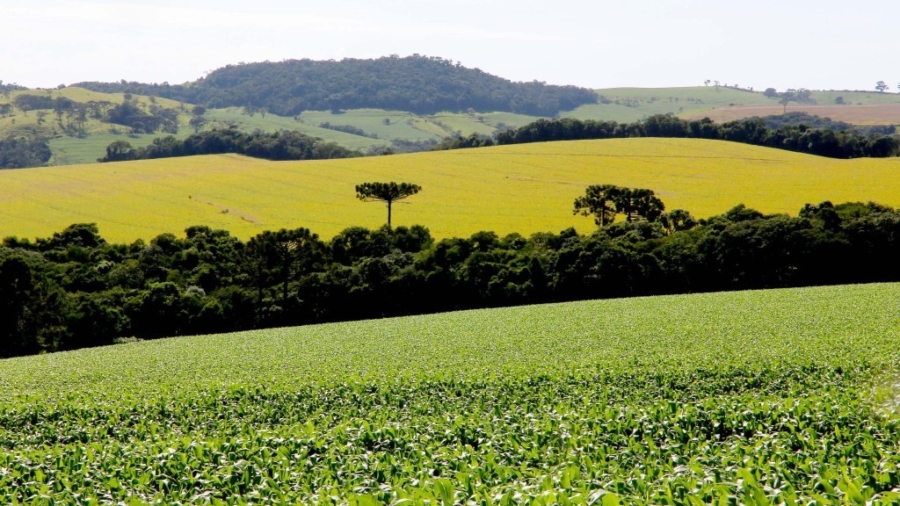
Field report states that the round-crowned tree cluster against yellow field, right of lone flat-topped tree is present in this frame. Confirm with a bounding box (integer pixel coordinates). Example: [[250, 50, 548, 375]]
[[572, 184, 666, 227]]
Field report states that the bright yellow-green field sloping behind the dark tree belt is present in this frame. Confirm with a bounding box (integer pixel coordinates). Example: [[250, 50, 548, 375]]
[[0, 139, 900, 242]]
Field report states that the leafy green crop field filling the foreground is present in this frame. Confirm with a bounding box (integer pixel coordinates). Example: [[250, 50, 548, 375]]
[[0, 284, 900, 505]]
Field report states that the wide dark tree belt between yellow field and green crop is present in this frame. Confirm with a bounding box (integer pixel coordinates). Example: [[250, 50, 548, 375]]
[[0, 202, 900, 356]]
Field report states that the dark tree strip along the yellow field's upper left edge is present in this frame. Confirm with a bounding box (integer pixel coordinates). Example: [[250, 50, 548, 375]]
[[97, 128, 362, 162]]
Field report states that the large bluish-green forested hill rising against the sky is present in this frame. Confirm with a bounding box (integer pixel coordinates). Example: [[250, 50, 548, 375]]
[[74, 55, 597, 116]]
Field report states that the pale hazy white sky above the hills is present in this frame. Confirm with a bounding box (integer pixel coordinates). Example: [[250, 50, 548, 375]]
[[0, 0, 900, 91]]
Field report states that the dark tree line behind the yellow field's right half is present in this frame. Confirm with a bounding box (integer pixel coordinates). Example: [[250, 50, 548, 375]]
[[492, 115, 900, 158]]
